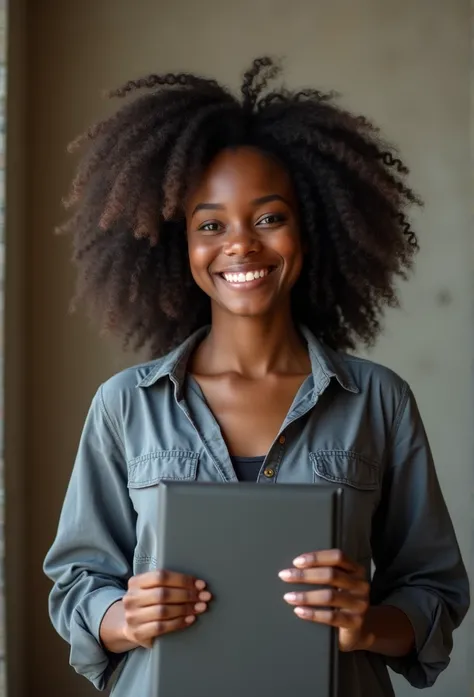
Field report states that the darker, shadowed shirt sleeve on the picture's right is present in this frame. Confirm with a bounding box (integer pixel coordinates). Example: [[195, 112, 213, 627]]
[[372, 384, 470, 688]]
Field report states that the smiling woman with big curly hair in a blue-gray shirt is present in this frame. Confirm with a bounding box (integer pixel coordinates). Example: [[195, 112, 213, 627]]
[[45, 58, 469, 697]]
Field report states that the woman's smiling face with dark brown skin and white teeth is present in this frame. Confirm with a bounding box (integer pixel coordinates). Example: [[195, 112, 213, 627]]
[[186, 147, 303, 317]]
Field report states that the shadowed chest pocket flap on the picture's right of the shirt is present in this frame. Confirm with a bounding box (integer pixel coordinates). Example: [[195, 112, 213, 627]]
[[310, 450, 380, 491]]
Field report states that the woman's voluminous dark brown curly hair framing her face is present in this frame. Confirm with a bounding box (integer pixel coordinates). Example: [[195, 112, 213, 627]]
[[60, 58, 421, 356]]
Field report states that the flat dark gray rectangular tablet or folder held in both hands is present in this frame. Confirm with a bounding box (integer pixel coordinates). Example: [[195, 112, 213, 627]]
[[151, 483, 342, 697]]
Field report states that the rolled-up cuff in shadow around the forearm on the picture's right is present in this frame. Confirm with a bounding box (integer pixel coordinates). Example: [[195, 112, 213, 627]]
[[382, 588, 452, 688]]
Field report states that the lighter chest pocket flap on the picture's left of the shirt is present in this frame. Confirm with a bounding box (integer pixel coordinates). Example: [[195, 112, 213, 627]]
[[128, 450, 199, 489]]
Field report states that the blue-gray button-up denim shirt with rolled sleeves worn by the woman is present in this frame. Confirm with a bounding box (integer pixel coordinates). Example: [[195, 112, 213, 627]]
[[44, 330, 469, 697]]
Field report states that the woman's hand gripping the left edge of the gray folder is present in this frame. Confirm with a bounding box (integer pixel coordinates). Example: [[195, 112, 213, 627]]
[[122, 570, 211, 648]]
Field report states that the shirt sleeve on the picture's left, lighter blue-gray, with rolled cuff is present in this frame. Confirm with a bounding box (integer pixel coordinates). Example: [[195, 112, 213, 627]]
[[44, 388, 136, 690]]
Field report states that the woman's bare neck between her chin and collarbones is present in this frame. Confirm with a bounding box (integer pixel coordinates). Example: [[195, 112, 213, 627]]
[[191, 311, 311, 379]]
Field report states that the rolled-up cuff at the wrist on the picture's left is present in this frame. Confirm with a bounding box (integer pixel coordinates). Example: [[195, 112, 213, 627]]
[[70, 587, 125, 690]]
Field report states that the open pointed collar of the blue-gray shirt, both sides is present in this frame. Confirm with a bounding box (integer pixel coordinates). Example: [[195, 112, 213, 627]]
[[137, 327, 360, 393]]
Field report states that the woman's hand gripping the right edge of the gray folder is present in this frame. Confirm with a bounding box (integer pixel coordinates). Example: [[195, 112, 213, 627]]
[[279, 549, 374, 651]]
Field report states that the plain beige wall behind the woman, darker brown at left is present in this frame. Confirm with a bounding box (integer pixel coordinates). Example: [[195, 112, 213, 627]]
[[6, 0, 474, 697]]
